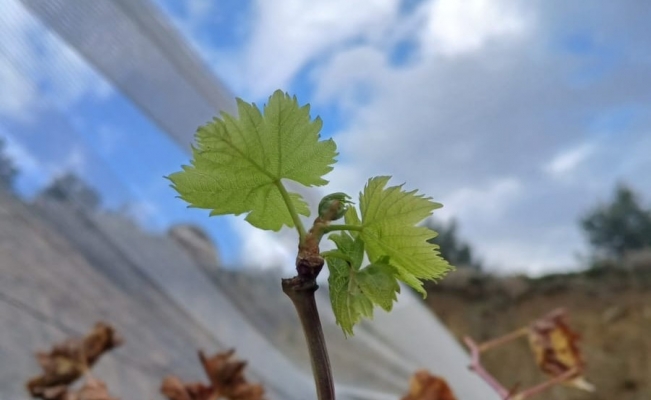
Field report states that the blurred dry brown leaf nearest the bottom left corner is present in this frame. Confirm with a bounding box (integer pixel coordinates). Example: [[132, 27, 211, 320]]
[[27, 322, 122, 400]]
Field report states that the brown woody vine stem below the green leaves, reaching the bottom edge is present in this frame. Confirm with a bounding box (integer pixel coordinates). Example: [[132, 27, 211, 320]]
[[282, 272, 335, 400]]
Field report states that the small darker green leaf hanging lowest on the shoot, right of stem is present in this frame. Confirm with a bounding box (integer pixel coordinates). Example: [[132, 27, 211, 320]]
[[323, 232, 400, 335]]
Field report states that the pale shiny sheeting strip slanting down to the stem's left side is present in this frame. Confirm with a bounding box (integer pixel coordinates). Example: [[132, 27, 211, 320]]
[[30, 200, 314, 399]]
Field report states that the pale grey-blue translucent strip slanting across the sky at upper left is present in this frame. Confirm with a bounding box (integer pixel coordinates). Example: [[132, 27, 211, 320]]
[[22, 0, 235, 149]]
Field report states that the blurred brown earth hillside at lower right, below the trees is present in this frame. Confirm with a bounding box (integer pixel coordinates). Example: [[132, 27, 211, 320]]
[[427, 263, 651, 400]]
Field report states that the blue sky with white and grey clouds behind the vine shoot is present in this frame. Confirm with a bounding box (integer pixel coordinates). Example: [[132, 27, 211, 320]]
[[0, 0, 651, 274]]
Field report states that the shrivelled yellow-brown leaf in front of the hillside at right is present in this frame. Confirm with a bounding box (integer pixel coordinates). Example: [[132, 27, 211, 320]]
[[529, 309, 594, 391]]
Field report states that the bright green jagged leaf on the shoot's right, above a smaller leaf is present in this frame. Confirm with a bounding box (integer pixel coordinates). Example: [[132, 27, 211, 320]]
[[346, 176, 452, 296]]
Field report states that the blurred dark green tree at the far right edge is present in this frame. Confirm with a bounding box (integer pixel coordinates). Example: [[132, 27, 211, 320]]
[[580, 185, 651, 259]]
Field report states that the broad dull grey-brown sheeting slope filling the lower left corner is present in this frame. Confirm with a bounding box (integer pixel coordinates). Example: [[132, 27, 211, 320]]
[[0, 190, 236, 400]]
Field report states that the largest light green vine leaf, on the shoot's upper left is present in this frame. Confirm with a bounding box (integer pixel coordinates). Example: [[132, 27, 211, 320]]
[[169, 90, 337, 231]]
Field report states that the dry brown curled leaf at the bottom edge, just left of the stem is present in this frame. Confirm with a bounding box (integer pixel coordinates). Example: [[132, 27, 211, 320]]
[[161, 350, 264, 400]]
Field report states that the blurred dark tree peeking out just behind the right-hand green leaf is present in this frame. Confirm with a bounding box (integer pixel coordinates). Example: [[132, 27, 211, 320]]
[[426, 218, 482, 271]]
